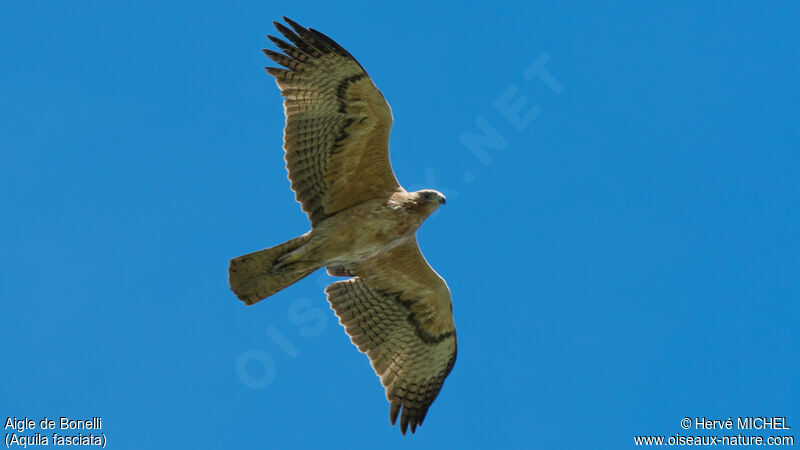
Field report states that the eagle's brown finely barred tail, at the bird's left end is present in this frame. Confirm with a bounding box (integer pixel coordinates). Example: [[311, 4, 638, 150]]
[[228, 233, 320, 305]]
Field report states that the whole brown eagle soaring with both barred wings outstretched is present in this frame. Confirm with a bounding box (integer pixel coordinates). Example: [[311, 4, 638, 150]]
[[228, 17, 456, 434]]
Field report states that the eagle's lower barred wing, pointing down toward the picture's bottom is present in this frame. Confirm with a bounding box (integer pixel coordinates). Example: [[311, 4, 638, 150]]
[[325, 238, 456, 434]]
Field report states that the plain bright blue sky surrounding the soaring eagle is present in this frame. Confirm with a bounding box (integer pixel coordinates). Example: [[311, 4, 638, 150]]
[[0, 1, 800, 449]]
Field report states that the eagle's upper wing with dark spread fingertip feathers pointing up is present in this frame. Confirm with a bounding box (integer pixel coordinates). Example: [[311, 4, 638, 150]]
[[264, 17, 400, 226]]
